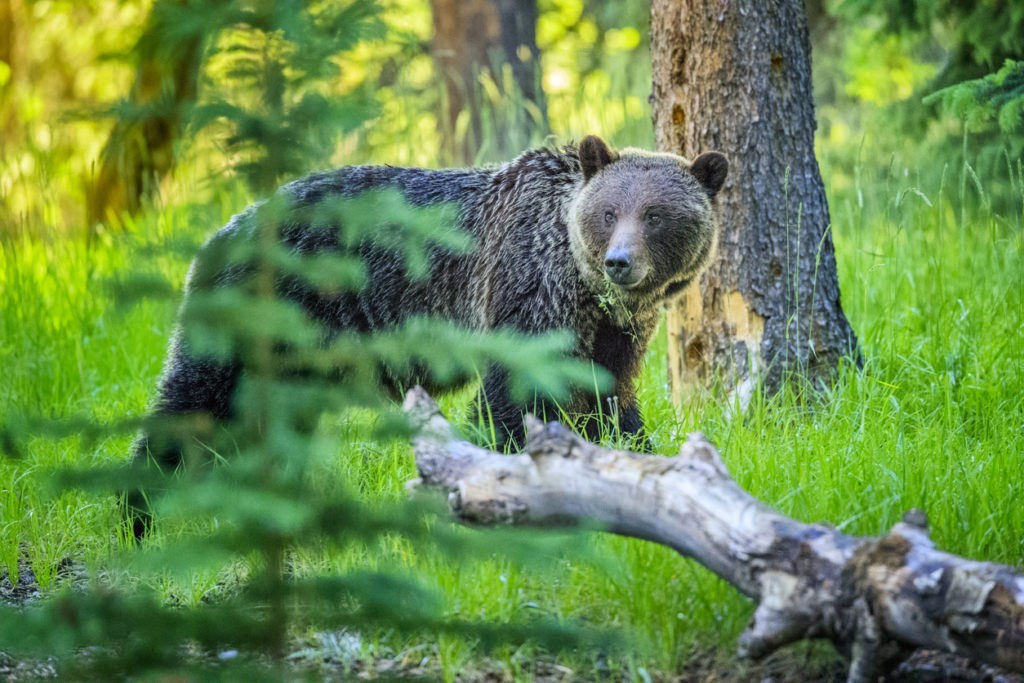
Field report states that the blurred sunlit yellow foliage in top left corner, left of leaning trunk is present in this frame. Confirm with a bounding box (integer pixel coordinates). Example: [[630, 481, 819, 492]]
[[0, 0, 148, 237]]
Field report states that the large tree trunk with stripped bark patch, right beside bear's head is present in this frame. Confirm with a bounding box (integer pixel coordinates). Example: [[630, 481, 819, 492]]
[[651, 0, 856, 400]]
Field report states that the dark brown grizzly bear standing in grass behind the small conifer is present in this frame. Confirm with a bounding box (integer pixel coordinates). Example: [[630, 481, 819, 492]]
[[135, 136, 728, 532]]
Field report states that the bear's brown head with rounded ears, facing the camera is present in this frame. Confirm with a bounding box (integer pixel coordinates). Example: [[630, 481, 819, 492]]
[[568, 136, 728, 304]]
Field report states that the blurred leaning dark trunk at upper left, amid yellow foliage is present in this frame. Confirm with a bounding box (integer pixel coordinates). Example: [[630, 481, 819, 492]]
[[86, 0, 203, 236]]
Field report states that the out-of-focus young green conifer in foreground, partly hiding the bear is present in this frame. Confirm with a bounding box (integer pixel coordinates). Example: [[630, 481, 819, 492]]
[[0, 1, 609, 678]]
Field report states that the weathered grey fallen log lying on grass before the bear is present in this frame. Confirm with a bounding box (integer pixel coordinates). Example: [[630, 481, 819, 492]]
[[404, 387, 1024, 681]]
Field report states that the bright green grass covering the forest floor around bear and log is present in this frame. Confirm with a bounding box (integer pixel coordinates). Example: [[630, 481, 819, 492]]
[[0, 149, 1024, 679]]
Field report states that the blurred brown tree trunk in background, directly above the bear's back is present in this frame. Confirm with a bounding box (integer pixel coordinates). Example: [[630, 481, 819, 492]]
[[430, 0, 547, 165]]
